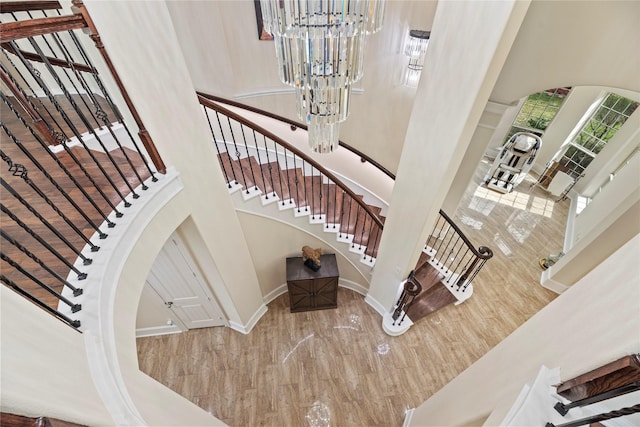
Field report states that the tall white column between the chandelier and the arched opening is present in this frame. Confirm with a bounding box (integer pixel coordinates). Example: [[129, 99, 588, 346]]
[[367, 0, 529, 311]]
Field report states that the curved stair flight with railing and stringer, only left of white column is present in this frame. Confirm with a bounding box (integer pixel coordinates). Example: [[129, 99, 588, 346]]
[[199, 95, 384, 279]]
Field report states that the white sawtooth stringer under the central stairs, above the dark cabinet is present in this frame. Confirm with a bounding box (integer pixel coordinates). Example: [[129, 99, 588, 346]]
[[230, 186, 375, 284]]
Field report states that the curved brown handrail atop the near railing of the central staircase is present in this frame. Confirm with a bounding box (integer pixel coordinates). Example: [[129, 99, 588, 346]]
[[198, 93, 384, 229]]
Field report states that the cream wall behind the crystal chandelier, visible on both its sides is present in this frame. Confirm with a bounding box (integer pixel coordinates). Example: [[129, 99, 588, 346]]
[[167, 0, 437, 172]]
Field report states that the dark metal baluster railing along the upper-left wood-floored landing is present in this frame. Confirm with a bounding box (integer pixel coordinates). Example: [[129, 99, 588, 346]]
[[0, 0, 164, 328]]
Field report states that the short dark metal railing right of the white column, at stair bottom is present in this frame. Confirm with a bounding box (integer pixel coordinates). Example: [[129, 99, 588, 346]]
[[425, 210, 493, 292]]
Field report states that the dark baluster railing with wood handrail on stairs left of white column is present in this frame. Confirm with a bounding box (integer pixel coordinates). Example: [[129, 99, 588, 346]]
[[198, 95, 383, 264]]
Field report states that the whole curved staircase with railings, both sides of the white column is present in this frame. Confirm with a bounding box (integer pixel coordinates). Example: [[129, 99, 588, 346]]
[[198, 93, 493, 335]]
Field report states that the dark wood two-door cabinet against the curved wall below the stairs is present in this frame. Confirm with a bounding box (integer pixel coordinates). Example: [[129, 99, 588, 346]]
[[287, 254, 340, 313]]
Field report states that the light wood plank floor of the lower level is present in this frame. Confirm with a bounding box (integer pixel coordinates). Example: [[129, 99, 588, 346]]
[[138, 162, 569, 427]]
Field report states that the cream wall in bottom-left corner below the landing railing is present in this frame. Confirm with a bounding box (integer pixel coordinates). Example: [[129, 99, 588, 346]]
[[0, 286, 113, 425]]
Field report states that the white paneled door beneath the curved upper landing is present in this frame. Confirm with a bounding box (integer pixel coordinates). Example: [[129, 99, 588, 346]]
[[147, 233, 226, 329]]
